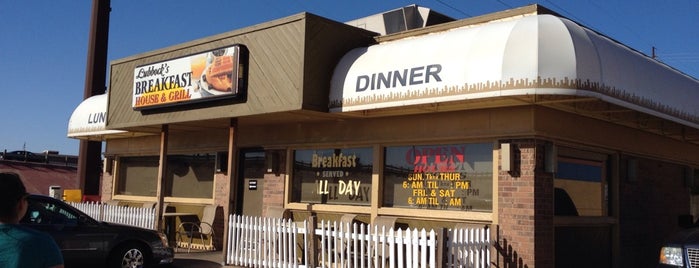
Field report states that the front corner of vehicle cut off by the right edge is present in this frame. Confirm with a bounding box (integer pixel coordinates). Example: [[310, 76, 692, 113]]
[[658, 226, 699, 267]]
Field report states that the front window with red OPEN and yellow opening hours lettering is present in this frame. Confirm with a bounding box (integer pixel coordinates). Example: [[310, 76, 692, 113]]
[[383, 143, 493, 212]]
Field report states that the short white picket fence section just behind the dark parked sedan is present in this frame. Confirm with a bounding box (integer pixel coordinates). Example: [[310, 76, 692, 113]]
[[68, 202, 156, 230]]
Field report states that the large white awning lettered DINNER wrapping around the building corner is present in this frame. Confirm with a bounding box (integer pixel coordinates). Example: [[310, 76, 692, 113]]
[[329, 15, 699, 128]]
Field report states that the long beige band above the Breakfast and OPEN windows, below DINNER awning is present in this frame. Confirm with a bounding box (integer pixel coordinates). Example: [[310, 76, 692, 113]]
[[238, 107, 533, 147]]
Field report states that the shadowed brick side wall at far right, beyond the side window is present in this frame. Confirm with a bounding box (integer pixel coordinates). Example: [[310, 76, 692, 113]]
[[619, 157, 690, 267]]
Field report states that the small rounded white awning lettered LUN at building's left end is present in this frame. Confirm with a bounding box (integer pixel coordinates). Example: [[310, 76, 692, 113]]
[[68, 94, 131, 141]]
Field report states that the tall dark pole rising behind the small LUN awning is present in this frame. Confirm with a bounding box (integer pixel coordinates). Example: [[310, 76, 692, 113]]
[[78, 0, 111, 195]]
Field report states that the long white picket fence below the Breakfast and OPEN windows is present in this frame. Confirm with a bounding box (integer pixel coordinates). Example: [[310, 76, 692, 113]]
[[226, 215, 492, 268]]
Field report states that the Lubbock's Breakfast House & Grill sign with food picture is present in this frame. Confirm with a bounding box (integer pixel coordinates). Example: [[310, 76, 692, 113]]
[[132, 45, 248, 110]]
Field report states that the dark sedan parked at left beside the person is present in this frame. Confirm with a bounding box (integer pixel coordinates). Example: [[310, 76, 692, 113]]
[[21, 195, 174, 267]]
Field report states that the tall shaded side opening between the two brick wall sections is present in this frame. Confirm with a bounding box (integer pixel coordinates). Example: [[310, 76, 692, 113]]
[[553, 148, 613, 267]]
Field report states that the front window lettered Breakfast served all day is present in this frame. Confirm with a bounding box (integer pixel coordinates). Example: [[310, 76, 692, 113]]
[[291, 148, 373, 206]]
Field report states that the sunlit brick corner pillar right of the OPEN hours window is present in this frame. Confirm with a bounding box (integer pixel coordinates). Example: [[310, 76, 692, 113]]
[[496, 140, 554, 268]]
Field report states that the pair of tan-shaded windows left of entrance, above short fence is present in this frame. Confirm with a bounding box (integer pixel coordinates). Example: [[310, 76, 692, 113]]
[[115, 154, 216, 198]]
